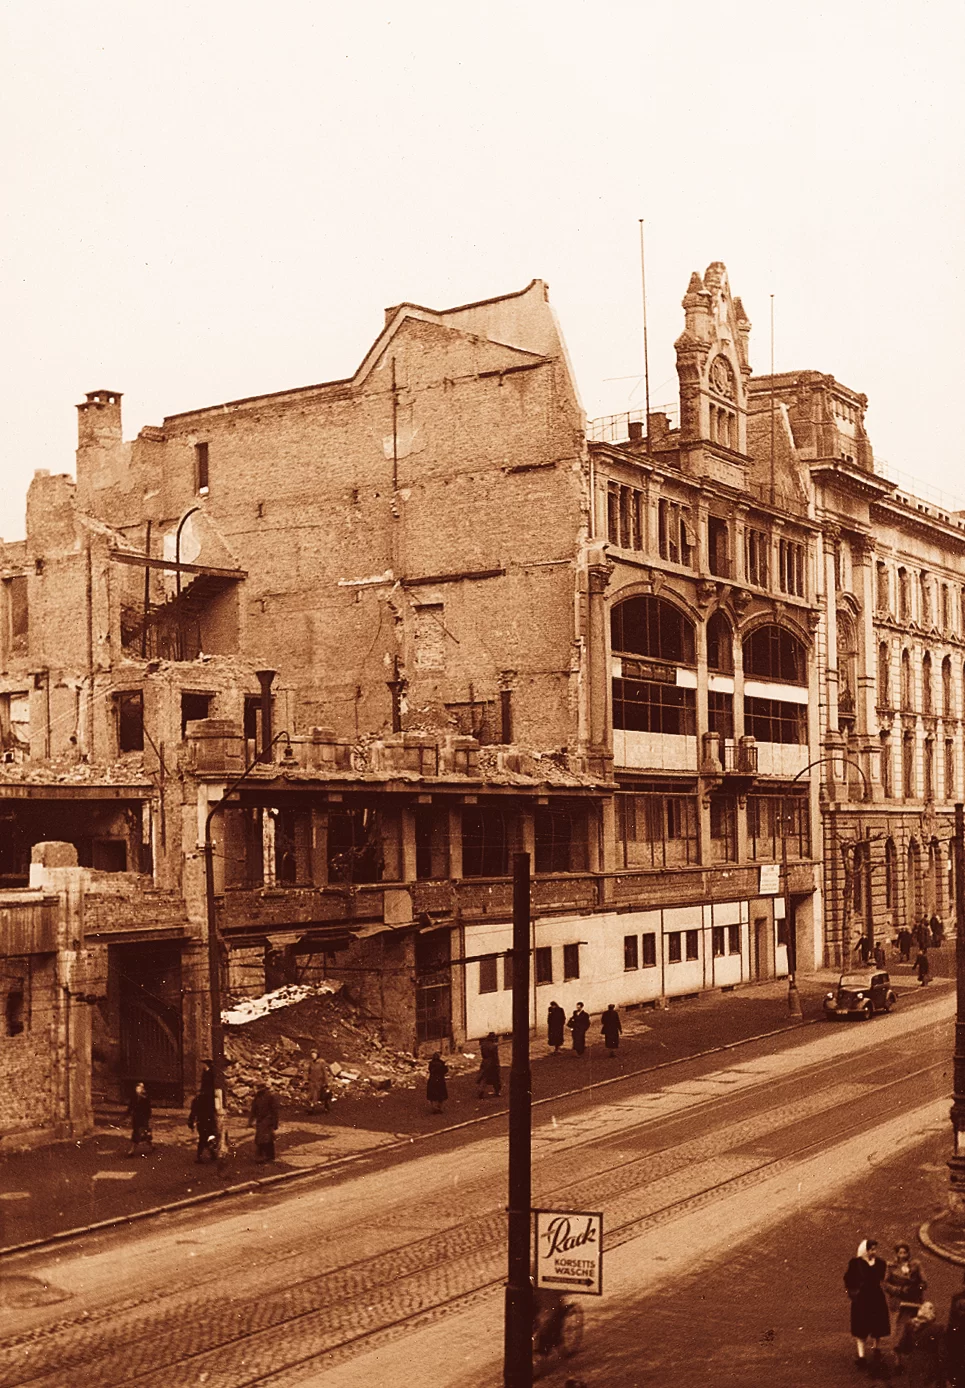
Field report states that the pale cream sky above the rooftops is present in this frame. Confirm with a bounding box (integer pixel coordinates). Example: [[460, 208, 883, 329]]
[[0, 0, 965, 539]]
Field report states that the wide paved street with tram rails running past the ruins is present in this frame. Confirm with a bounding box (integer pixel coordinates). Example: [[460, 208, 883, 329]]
[[0, 995, 954, 1388]]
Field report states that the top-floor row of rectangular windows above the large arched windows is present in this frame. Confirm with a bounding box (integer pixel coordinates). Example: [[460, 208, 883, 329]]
[[607, 496, 807, 597]]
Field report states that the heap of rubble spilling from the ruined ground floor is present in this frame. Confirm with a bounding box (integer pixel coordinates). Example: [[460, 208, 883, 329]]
[[222, 981, 478, 1113]]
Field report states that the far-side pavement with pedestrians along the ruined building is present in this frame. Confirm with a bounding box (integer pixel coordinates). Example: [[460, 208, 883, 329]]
[[0, 948, 954, 1252]]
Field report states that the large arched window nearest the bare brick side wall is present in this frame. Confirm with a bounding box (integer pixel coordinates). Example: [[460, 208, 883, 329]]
[[610, 594, 697, 737]]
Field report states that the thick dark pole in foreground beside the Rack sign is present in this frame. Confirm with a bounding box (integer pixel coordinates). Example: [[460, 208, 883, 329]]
[[503, 854, 533, 1388]]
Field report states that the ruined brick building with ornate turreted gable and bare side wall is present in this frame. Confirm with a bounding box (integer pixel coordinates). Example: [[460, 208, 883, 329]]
[[0, 264, 961, 1143]]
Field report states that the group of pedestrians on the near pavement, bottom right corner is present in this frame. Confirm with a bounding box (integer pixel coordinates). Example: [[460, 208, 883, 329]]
[[844, 1238, 965, 1388]]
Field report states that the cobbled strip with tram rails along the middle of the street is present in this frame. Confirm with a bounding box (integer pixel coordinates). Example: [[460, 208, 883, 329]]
[[0, 1059, 946, 1388]]
